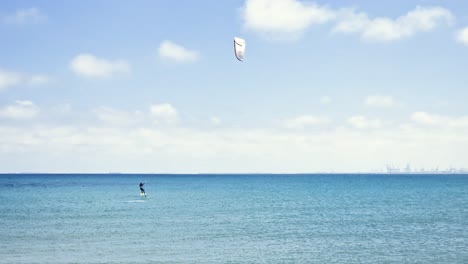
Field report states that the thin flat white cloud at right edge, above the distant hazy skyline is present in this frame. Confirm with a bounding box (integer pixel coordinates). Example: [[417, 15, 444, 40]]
[[411, 111, 468, 128]]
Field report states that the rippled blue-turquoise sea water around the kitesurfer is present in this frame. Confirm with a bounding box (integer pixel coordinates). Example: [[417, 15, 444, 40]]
[[0, 174, 468, 264]]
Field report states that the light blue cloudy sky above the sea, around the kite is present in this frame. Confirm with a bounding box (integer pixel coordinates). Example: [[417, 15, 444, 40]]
[[0, 0, 468, 173]]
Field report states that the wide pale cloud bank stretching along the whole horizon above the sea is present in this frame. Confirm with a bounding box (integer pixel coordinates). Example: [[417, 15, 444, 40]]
[[0, 120, 468, 173]]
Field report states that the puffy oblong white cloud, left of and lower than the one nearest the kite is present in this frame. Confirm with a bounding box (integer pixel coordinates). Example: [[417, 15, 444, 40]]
[[70, 54, 130, 78]]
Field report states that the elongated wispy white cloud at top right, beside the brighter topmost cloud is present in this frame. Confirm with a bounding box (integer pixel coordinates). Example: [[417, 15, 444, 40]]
[[333, 7, 454, 41]]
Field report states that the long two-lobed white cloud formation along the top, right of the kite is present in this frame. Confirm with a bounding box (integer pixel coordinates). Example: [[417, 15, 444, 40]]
[[241, 0, 454, 42]]
